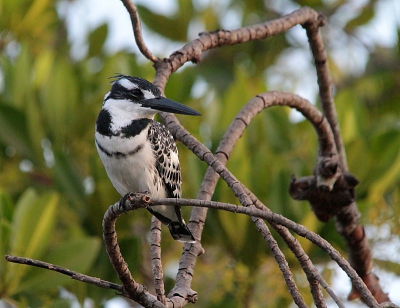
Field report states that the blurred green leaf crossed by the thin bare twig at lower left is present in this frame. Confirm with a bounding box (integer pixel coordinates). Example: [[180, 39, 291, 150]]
[[18, 237, 101, 293]]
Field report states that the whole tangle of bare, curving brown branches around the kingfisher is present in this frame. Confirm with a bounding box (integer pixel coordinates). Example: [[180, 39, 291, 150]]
[[6, 0, 395, 307]]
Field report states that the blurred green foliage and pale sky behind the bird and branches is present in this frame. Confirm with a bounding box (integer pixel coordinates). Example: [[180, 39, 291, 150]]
[[0, 0, 400, 307]]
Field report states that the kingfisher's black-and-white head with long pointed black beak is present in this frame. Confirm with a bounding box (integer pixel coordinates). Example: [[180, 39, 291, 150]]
[[103, 75, 201, 118]]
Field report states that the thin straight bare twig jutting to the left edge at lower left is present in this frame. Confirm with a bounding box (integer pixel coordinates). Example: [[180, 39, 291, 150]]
[[5, 255, 123, 296]]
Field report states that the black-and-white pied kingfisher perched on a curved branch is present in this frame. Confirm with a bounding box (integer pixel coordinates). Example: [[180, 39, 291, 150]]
[[95, 75, 201, 242]]
